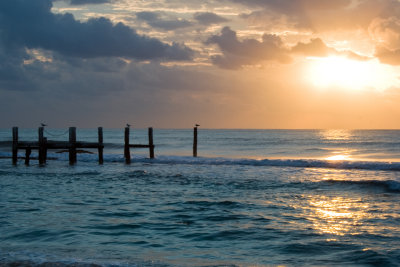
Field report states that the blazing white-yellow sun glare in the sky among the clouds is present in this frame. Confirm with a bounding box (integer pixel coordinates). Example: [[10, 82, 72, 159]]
[[308, 56, 399, 91]]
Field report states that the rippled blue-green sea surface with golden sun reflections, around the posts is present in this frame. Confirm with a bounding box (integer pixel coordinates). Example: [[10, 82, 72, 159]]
[[0, 128, 400, 266]]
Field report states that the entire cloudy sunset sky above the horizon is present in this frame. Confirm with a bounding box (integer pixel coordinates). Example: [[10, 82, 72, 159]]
[[0, 0, 400, 129]]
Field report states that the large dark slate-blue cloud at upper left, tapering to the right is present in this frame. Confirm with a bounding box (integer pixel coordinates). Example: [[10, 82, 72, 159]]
[[0, 0, 193, 60]]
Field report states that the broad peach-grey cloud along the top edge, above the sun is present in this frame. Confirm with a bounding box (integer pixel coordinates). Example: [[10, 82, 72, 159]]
[[230, 0, 400, 33]]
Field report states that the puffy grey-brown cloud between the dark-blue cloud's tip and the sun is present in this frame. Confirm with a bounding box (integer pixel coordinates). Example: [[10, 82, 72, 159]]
[[206, 27, 290, 69]]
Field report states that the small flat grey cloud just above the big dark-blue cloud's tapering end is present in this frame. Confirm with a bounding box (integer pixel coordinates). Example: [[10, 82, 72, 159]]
[[136, 11, 192, 31]]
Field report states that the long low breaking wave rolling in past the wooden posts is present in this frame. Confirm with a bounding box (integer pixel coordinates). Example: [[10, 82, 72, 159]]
[[0, 152, 400, 171]]
